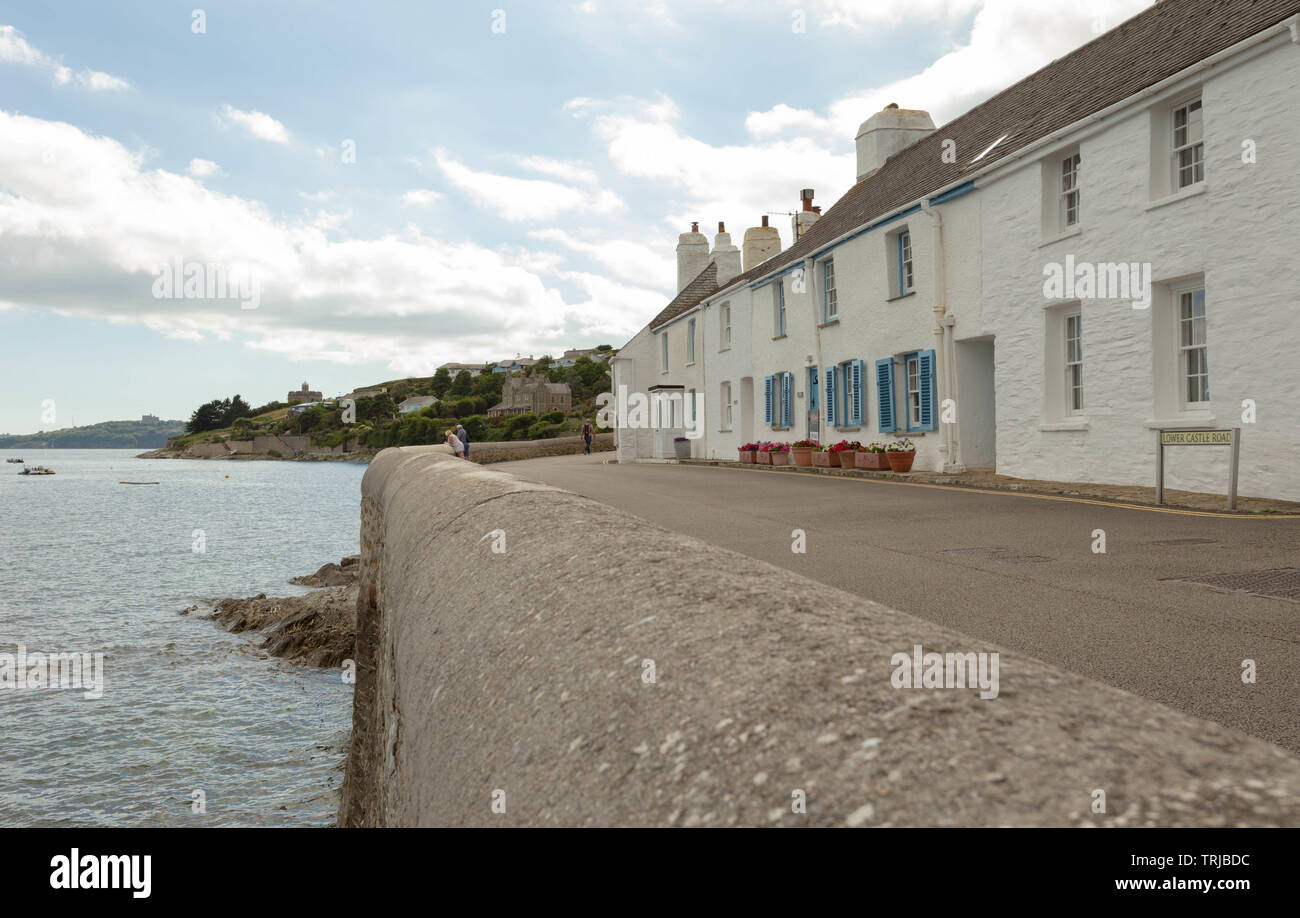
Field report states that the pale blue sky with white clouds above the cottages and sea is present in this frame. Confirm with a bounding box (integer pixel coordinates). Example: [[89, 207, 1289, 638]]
[[0, 0, 1149, 433]]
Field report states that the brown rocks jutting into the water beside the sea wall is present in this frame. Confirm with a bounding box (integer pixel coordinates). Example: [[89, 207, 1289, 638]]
[[179, 555, 360, 668]]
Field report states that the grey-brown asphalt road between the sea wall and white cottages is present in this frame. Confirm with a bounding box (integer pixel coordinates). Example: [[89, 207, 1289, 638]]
[[493, 454, 1300, 752]]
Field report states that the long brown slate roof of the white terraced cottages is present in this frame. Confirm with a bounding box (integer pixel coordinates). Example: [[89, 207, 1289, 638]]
[[712, 0, 1300, 299]]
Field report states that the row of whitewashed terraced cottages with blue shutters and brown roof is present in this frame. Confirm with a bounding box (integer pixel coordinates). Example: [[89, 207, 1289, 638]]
[[612, 0, 1300, 499]]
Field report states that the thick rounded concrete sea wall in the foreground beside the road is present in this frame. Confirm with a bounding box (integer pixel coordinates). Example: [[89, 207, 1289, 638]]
[[339, 446, 1300, 826]]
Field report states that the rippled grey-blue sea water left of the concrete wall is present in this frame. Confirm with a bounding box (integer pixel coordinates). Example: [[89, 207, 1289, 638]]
[[0, 450, 365, 826]]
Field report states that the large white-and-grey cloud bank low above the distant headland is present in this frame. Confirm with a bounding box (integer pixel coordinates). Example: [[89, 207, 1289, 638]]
[[0, 111, 650, 372]]
